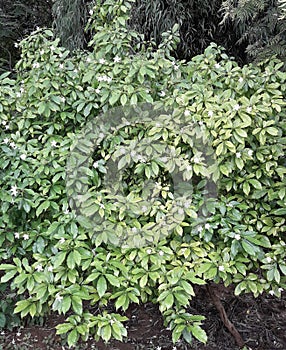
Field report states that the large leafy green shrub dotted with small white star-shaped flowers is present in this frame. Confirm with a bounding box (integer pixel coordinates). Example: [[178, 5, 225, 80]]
[[0, 0, 286, 346]]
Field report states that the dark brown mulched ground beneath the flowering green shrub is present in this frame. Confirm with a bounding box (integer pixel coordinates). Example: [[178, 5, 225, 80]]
[[0, 286, 286, 350]]
